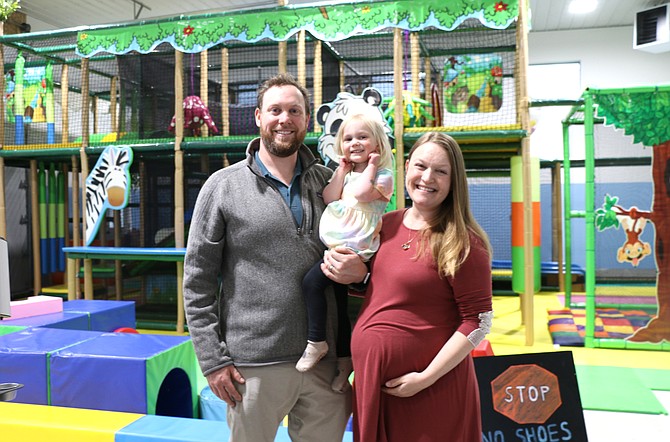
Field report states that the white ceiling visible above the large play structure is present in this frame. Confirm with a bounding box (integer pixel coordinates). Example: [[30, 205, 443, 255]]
[[13, 0, 670, 32]]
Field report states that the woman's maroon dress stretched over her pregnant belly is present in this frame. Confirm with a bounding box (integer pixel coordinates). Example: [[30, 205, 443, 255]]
[[351, 211, 492, 442]]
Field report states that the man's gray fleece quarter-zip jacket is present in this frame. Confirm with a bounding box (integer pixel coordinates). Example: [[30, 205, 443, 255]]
[[184, 139, 336, 375]]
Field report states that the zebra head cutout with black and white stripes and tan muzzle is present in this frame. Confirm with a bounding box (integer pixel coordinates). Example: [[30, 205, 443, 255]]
[[85, 146, 133, 246]]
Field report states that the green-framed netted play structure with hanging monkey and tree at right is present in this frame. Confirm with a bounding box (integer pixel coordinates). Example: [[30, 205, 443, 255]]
[[550, 86, 670, 351]]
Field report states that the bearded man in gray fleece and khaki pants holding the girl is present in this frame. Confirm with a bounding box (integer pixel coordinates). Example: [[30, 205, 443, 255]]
[[184, 74, 367, 442]]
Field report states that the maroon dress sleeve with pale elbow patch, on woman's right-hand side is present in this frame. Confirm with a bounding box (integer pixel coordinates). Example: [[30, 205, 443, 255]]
[[450, 235, 493, 347]]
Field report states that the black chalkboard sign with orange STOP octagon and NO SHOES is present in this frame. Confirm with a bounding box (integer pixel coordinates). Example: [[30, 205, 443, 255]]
[[474, 351, 588, 442]]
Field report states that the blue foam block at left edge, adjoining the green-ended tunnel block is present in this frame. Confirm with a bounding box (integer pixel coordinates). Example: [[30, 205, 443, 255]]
[[0, 328, 100, 404]]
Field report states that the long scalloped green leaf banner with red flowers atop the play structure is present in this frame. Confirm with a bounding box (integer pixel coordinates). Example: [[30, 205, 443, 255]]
[[77, 0, 518, 57]]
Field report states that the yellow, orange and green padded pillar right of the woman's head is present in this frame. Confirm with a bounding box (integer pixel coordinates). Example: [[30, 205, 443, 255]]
[[511, 156, 542, 294]]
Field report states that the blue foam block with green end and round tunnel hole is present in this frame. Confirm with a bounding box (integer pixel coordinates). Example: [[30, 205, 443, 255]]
[[49, 333, 198, 417]]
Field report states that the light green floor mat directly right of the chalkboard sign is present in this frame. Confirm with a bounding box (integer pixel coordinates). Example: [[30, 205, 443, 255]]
[[575, 365, 668, 414]]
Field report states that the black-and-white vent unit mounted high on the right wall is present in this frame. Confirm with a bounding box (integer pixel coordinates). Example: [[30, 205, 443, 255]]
[[633, 4, 670, 54]]
